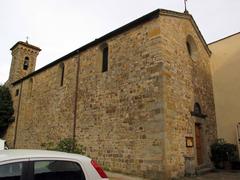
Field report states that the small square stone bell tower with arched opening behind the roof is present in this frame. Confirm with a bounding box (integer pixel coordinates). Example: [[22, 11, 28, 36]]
[[8, 41, 41, 83]]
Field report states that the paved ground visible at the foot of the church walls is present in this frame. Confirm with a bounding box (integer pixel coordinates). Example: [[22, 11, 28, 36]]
[[107, 171, 240, 180]]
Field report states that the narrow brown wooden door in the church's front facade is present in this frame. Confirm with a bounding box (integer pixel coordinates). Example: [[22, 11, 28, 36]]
[[195, 124, 203, 165]]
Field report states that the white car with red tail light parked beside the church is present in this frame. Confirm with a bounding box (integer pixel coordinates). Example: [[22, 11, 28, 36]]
[[0, 150, 108, 180]]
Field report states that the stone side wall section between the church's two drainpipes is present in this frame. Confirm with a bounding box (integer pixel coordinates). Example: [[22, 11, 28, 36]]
[[12, 58, 76, 148]]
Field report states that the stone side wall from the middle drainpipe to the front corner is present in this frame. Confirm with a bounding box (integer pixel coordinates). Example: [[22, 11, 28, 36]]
[[76, 19, 163, 177]]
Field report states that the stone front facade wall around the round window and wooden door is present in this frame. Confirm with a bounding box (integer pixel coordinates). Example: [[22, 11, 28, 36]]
[[160, 16, 216, 177]]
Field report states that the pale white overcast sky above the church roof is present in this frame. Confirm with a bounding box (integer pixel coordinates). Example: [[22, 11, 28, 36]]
[[0, 0, 240, 83]]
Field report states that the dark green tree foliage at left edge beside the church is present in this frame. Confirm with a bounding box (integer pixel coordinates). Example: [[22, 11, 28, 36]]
[[0, 85, 14, 137]]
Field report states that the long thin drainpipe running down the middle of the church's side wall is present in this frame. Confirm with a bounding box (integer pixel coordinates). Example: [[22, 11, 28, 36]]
[[73, 51, 80, 149]]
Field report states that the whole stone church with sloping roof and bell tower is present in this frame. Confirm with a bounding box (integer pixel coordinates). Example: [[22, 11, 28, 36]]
[[6, 9, 217, 179]]
